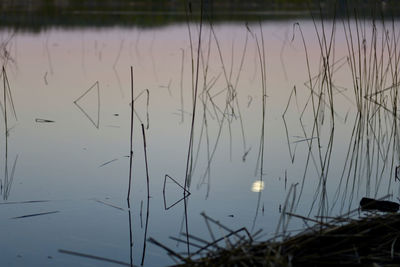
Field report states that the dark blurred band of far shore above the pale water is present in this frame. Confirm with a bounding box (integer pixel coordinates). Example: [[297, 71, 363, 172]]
[[0, 0, 400, 31]]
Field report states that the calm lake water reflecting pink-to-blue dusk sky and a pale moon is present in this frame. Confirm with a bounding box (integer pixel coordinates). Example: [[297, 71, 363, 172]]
[[0, 17, 400, 266]]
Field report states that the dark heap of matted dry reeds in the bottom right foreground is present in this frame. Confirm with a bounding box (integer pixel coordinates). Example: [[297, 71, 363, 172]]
[[173, 213, 400, 266]]
